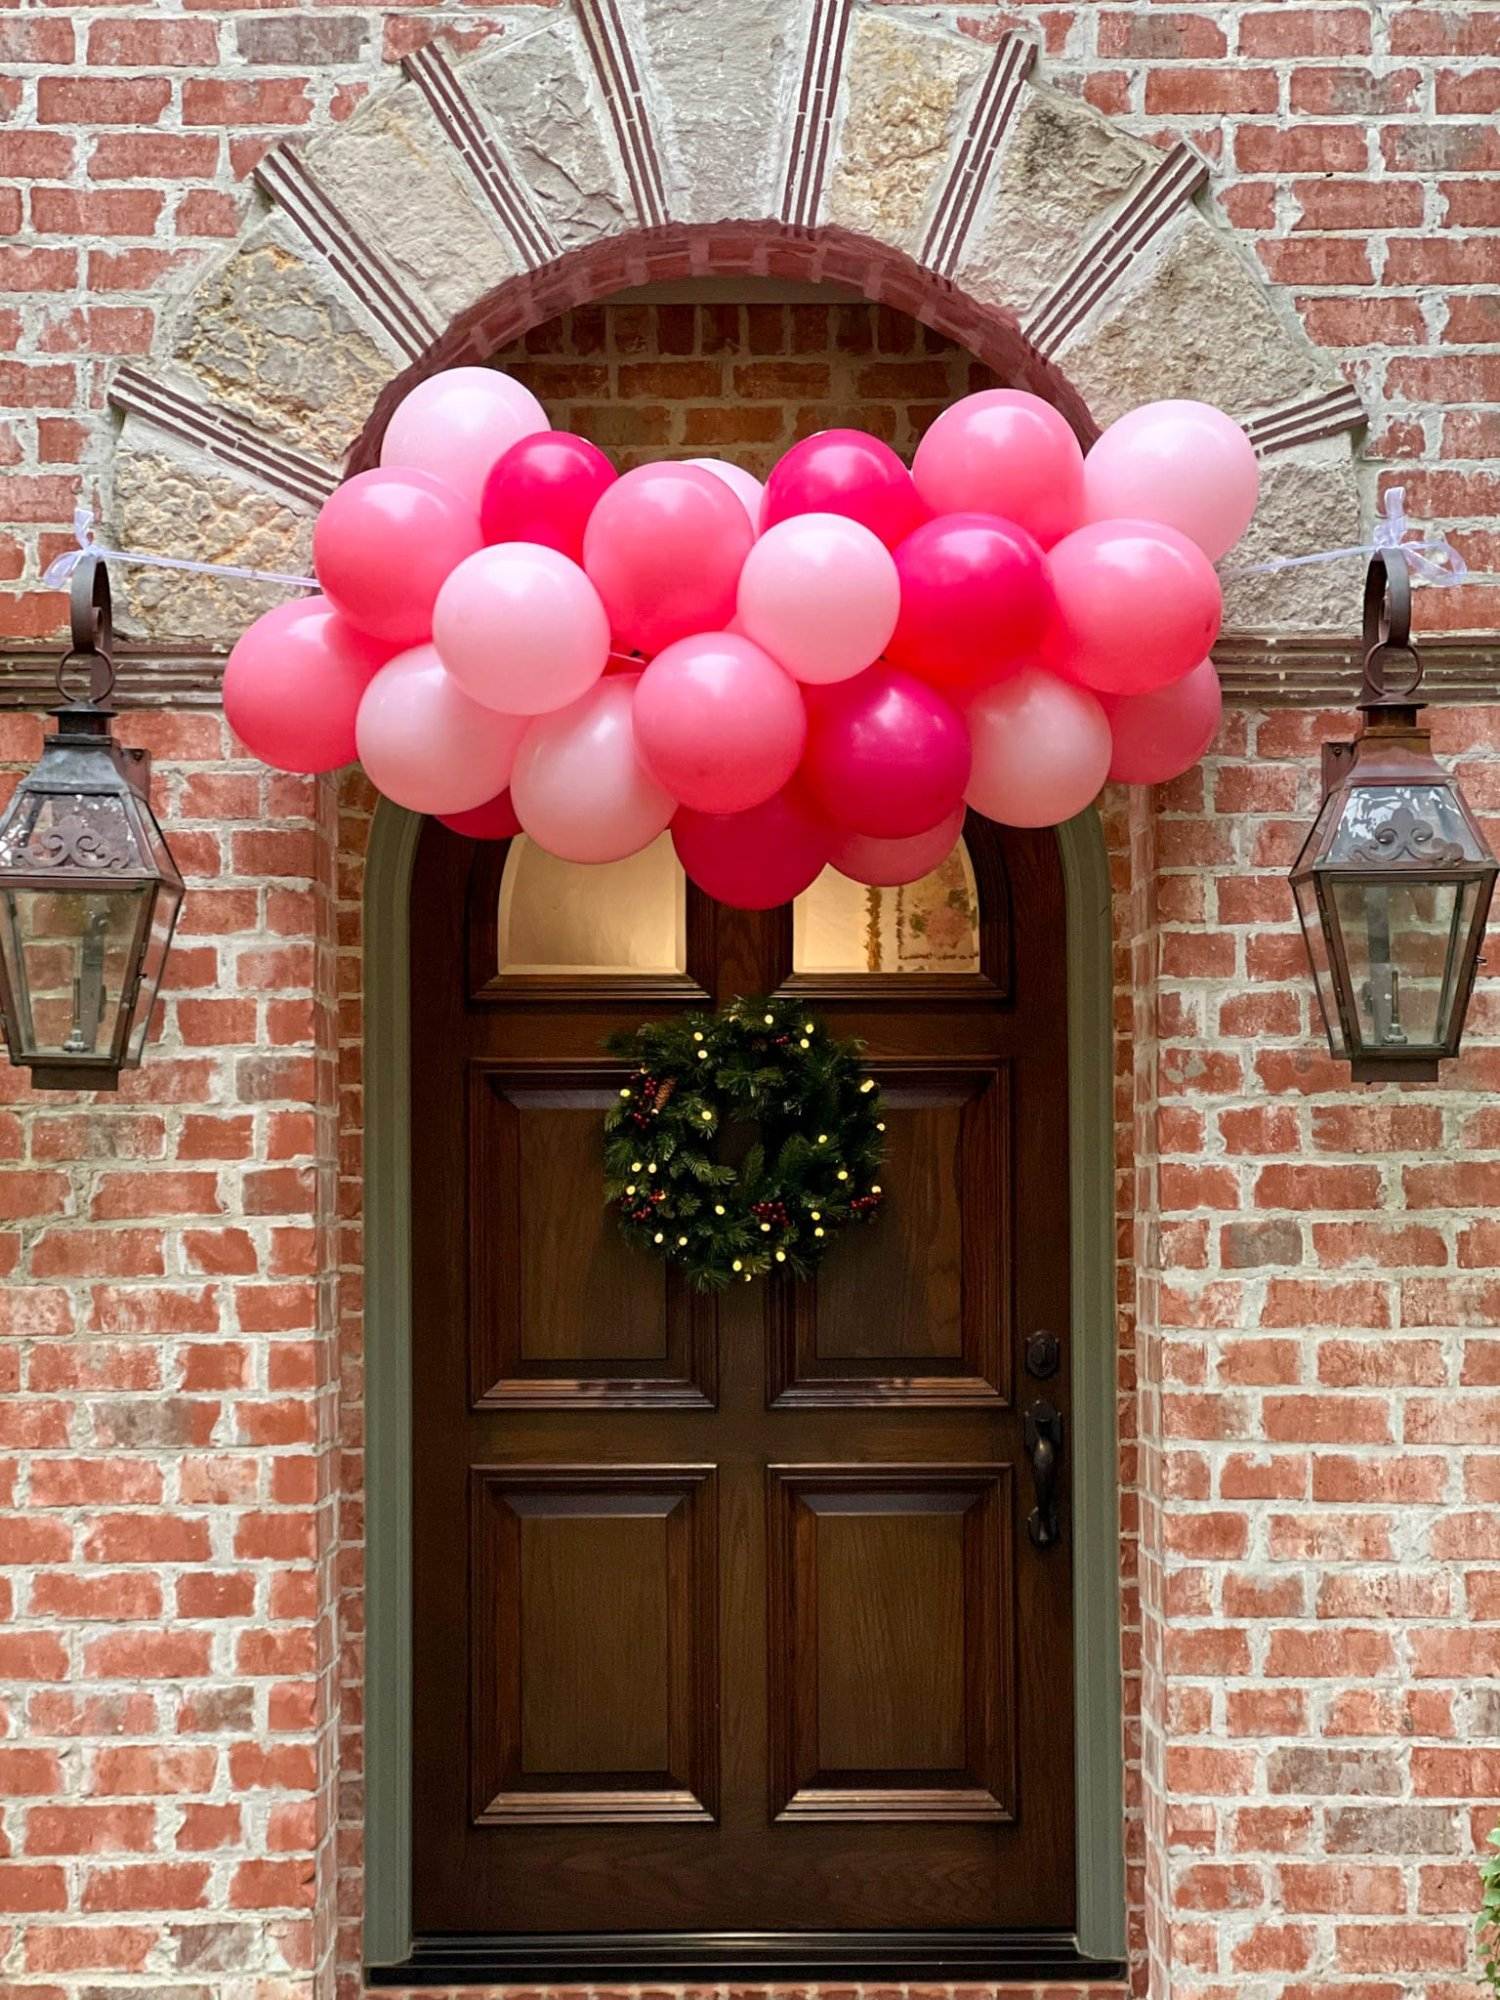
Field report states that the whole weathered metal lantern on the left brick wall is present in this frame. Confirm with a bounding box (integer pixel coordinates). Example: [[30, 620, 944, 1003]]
[[0, 556, 182, 1090]]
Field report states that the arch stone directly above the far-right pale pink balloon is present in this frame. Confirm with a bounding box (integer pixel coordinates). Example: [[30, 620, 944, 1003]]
[[1056, 208, 1336, 424]]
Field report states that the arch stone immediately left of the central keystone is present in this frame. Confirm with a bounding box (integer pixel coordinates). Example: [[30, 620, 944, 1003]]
[[460, 10, 636, 250]]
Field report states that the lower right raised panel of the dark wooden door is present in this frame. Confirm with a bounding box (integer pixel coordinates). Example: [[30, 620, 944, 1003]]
[[766, 1464, 1016, 1820]]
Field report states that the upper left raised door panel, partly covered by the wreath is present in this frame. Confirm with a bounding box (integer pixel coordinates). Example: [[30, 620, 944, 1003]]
[[468, 1062, 716, 1408]]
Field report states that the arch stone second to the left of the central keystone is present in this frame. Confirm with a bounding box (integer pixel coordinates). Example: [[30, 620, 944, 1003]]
[[306, 84, 520, 324]]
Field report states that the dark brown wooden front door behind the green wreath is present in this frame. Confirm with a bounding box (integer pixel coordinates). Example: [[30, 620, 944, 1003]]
[[412, 820, 1074, 1934]]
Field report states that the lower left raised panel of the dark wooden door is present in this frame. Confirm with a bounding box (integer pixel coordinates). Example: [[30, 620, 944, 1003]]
[[468, 1466, 718, 1826]]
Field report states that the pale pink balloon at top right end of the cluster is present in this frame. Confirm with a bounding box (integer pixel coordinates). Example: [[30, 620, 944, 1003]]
[[1084, 402, 1260, 562]]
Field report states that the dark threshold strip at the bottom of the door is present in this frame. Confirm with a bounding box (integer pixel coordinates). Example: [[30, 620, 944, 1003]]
[[366, 1930, 1124, 1986]]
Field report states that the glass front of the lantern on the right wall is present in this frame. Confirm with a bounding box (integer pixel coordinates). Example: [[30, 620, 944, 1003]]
[[1332, 876, 1478, 1054]]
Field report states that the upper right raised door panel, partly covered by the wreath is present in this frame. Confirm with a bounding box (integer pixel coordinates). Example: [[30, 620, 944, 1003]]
[[766, 1062, 1014, 1406]]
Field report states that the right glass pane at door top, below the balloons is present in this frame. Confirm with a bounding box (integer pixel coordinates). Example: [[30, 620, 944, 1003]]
[[792, 840, 980, 974]]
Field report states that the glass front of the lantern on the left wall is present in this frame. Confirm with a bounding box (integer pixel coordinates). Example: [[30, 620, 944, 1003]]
[[0, 882, 150, 1062]]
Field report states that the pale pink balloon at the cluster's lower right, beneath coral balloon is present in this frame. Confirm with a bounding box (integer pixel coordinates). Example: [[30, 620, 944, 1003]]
[[964, 666, 1112, 826]]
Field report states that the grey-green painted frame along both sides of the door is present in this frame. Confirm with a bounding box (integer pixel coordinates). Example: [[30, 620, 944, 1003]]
[[364, 800, 1126, 1978]]
